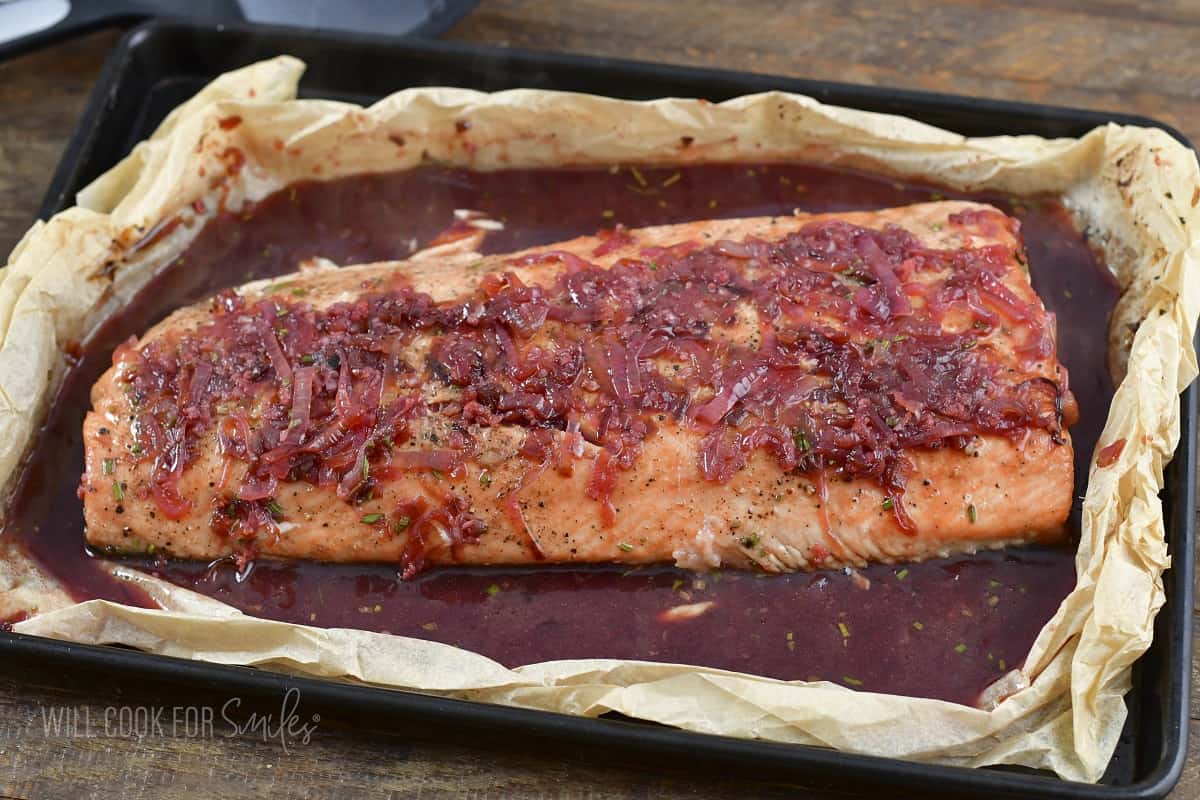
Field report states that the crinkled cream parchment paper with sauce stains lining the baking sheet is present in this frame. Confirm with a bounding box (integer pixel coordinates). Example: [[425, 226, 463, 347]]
[[0, 56, 1200, 781]]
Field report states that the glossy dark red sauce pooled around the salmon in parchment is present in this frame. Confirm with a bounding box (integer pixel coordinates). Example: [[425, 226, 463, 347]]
[[5, 164, 1117, 703]]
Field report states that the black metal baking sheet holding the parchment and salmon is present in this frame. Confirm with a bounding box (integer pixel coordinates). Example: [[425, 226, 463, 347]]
[[0, 23, 1196, 798]]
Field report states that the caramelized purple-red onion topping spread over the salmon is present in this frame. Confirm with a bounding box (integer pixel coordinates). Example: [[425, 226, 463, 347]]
[[114, 212, 1073, 561]]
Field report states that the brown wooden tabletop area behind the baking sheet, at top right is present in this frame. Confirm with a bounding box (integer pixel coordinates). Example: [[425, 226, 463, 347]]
[[451, 0, 1200, 132]]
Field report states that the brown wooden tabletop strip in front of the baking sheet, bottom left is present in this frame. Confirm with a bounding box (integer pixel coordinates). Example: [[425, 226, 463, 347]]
[[0, 675, 825, 800]]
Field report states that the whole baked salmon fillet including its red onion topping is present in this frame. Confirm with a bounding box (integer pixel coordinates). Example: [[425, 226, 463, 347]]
[[79, 201, 1076, 577]]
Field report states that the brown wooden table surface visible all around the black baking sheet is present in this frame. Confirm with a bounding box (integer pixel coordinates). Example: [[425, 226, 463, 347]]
[[0, 0, 1200, 800]]
